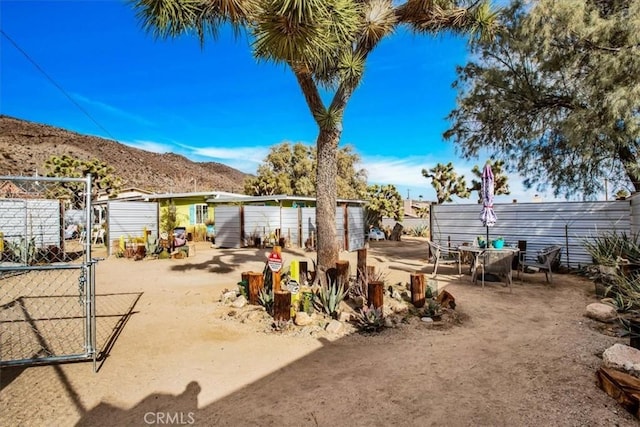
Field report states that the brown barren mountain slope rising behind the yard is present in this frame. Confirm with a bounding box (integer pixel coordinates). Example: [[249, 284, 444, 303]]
[[0, 115, 248, 193]]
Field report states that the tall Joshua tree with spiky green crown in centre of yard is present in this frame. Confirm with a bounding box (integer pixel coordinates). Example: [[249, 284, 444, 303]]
[[131, 0, 497, 269]]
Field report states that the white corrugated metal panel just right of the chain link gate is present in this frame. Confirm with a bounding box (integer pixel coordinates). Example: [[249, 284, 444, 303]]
[[107, 200, 158, 241]]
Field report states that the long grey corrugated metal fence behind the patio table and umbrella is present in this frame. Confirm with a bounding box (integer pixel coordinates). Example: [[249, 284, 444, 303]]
[[432, 201, 631, 267]]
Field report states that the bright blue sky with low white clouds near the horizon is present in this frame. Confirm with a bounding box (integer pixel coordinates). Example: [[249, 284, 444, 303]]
[[0, 0, 550, 203]]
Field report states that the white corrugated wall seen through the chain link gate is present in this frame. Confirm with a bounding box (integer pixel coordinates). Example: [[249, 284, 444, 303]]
[[0, 199, 61, 247]]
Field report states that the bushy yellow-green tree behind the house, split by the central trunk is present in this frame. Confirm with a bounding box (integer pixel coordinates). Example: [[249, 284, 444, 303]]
[[244, 142, 367, 199]]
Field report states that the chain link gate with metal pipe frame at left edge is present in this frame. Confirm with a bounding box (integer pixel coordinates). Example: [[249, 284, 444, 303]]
[[0, 176, 97, 371]]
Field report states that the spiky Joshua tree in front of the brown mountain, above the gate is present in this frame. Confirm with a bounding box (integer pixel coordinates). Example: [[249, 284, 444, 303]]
[[44, 154, 122, 208]]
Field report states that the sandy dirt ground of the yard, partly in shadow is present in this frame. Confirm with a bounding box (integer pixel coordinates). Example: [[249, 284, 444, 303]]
[[0, 238, 637, 426]]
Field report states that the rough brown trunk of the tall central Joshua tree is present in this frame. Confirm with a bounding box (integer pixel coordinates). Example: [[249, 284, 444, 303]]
[[316, 126, 342, 277]]
